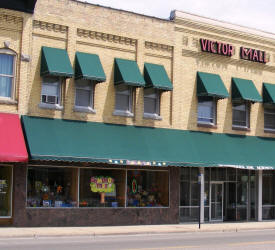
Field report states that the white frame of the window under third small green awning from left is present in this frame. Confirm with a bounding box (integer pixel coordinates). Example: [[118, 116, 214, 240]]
[[113, 85, 134, 117]]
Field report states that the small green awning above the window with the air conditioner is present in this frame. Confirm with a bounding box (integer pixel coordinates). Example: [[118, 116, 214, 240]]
[[40, 46, 74, 77]]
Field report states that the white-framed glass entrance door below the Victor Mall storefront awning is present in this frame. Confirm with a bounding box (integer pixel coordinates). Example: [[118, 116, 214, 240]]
[[209, 182, 223, 221]]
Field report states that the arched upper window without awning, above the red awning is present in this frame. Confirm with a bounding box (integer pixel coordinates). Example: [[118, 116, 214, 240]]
[[0, 49, 15, 98]]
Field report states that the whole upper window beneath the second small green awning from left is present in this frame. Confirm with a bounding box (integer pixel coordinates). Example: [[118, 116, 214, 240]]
[[75, 79, 95, 112]]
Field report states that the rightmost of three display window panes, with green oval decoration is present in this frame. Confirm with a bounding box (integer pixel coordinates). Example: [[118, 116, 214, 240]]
[[127, 170, 169, 207]]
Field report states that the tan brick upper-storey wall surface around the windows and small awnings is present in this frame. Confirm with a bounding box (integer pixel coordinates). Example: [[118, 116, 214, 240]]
[[0, 0, 275, 137]]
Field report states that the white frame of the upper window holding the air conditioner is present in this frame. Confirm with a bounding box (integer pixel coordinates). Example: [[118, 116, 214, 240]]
[[39, 76, 63, 110]]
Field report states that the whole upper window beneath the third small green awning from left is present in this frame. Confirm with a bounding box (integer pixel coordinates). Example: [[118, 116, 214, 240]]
[[114, 84, 133, 116]]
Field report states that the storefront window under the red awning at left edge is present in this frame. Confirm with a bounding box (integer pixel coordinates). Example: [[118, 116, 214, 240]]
[[0, 166, 12, 217]]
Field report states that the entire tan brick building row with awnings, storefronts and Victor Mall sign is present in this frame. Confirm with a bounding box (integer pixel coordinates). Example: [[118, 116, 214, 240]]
[[0, 0, 275, 226]]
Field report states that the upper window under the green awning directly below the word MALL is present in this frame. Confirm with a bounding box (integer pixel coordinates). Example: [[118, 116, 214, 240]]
[[232, 101, 250, 129]]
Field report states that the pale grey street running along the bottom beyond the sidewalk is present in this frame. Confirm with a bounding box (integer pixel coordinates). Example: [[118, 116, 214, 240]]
[[0, 229, 275, 250]]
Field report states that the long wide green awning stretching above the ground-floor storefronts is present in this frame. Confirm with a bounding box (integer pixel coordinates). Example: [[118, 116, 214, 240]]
[[22, 116, 275, 169]]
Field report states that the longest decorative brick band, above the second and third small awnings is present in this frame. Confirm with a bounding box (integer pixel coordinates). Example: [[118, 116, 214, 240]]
[[77, 29, 137, 46]]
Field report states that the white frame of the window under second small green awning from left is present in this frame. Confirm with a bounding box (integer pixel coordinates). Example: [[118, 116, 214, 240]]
[[74, 79, 96, 113]]
